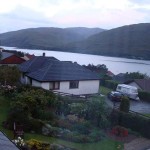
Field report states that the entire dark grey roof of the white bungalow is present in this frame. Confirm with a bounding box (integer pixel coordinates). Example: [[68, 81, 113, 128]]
[[19, 56, 100, 82]]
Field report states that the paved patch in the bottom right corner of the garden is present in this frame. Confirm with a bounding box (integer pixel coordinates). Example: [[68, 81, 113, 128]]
[[124, 138, 150, 150]]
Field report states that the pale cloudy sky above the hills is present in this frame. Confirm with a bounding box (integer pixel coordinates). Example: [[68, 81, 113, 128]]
[[0, 0, 150, 33]]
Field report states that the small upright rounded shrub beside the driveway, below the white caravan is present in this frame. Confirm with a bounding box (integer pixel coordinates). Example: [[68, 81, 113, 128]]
[[120, 96, 130, 112]]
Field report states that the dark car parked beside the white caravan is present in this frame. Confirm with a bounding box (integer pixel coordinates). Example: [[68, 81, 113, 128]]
[[108, 91, 124, 102]]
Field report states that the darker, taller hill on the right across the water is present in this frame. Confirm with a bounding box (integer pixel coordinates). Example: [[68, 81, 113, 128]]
[[64, 23, 150, 59]]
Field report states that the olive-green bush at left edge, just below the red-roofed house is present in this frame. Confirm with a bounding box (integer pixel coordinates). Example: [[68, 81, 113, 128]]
[[0, 66, 20, 85]]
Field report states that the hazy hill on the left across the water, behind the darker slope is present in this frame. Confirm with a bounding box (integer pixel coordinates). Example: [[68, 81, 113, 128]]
[[0, 27, 104, 50]]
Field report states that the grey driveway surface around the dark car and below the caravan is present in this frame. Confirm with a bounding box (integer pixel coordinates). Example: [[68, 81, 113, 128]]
[[106, 97, 150, 114]]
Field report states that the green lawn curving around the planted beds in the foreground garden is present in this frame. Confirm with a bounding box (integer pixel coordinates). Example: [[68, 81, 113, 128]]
[[0, 96, 123, 150]]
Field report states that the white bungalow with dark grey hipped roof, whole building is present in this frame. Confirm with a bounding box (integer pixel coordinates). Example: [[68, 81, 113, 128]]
[[19, 56, 100, 95]]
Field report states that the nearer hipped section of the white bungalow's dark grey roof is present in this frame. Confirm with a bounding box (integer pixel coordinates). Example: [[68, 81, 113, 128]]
[[27, 60, 100, 82]]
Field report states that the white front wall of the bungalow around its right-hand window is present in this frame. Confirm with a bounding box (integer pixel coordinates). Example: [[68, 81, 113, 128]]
[[55, 80, 99, 95]]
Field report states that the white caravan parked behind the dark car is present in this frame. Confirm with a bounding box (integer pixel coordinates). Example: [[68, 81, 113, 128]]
[[116, 84, 140, 100]]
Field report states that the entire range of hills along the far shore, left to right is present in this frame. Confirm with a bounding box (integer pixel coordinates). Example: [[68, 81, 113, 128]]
[[0, 23, 150, 60]]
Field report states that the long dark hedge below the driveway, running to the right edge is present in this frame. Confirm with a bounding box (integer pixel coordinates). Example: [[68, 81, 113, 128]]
[[111, 110, 150, 138]]
